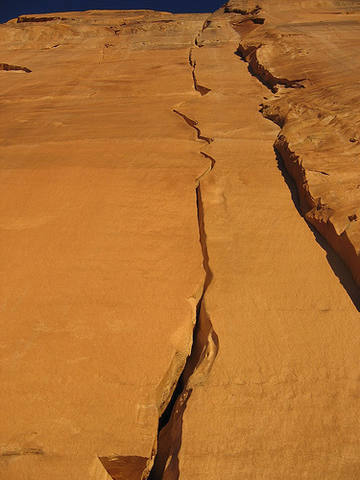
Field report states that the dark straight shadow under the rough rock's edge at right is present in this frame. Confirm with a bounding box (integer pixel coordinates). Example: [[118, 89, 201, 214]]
[[274, 148, 360, 312]]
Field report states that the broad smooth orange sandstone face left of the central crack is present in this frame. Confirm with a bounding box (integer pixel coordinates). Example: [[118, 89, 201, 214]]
[[0, 11, 207, 480]]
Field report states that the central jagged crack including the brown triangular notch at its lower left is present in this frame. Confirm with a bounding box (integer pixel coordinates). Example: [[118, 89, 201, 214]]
[[94, 22, 219, 480]]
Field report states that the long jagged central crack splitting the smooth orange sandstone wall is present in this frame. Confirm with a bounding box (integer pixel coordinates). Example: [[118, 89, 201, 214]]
[[149, 28, 219, 480]]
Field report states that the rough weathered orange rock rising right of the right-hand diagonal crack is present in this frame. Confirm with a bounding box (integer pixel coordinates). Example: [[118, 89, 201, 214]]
[[228, 0, 360, 284]]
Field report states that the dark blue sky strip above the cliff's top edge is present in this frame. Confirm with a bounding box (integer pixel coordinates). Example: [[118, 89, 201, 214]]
[[0, 0, 226, 22]]
